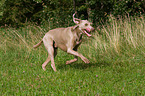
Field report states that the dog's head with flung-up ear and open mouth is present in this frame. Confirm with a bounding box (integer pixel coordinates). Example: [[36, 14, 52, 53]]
[[73, 12, 94, 37]]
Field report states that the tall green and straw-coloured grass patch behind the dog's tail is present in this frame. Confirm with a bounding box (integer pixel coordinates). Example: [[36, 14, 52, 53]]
[[0, 25, 42, 52]]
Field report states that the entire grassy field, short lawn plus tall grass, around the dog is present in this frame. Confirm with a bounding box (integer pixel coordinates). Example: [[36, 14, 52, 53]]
[[0, 16, 145, 96]]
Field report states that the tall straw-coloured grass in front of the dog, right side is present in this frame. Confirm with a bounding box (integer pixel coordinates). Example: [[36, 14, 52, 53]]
[[84, 16, 145, 60]]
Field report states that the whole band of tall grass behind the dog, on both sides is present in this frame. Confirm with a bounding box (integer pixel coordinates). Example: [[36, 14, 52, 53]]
[[0, 16, 145, 55]]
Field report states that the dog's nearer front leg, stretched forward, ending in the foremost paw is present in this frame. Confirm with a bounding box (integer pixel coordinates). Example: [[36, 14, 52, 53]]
[[67, 48, 90, 63]]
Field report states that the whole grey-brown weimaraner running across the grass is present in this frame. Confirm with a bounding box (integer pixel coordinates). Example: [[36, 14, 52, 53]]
[[33, 13, 94, 71]]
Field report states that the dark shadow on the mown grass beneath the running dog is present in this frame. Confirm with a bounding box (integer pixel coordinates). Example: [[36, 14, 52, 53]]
[[57, 62, 110, 69]]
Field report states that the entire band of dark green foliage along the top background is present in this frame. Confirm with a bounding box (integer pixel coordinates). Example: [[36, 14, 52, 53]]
[[0, 0, 145, 28]]
